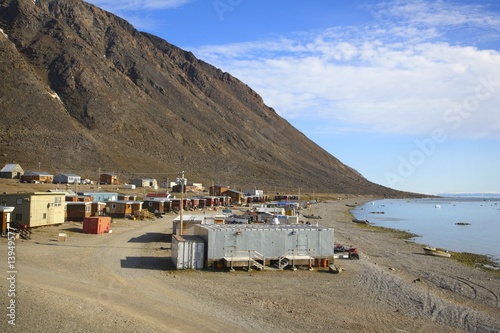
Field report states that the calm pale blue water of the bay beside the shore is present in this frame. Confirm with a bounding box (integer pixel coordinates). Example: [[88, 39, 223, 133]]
[[352, 196, 500, 262]]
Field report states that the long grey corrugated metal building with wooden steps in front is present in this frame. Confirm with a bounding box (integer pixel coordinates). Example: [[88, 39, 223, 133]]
[[194, 224, 334, 269]]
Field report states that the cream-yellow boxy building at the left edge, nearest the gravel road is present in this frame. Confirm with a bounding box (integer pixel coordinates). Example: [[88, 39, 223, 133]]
[[0, 192, 66, 227]]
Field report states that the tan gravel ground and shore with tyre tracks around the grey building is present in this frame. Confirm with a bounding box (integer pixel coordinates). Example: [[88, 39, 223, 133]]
[[0, 197, 500, 333]]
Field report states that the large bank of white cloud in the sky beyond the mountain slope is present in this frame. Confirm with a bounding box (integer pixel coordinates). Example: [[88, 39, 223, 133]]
[[193, 1, 500, 137]]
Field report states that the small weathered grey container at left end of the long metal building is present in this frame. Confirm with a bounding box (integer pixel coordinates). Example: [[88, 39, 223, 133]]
[[172, 235, 205, 269]]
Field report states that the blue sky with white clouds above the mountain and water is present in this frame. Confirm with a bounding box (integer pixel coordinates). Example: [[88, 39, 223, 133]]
[[89, 0, 500, 194]]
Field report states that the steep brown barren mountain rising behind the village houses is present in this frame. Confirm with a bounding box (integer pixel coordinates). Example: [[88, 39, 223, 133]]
[[0, 0, 410, 195]]
